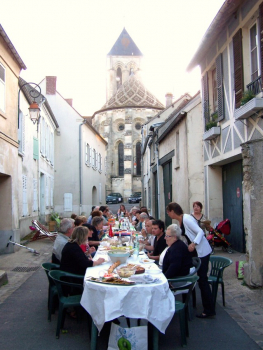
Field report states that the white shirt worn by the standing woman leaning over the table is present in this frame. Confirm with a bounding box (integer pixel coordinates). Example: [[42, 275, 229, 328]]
[[183, 214, 212, 258]]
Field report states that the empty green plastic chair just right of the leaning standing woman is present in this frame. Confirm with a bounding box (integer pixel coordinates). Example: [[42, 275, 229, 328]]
[[208, 255, 233, 306]]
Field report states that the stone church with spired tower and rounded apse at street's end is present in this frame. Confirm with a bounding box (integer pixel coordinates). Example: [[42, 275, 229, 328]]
[[92, 28, 164, 199]]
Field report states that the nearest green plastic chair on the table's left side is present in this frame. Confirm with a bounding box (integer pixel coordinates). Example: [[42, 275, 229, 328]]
[[48, 270, 84, 339]]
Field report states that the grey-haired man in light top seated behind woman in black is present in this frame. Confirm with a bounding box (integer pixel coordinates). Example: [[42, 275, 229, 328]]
[[52, 218, 75, 264]]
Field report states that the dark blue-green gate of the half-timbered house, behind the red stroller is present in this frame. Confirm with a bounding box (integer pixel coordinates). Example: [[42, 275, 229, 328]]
[[222, 160, 245, 253]]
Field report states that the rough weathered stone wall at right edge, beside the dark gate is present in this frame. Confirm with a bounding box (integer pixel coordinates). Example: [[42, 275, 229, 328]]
[[241, 139, 263, 287]]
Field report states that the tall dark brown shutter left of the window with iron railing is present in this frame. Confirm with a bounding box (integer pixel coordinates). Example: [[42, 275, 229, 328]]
[[233, 28, 244, 108]]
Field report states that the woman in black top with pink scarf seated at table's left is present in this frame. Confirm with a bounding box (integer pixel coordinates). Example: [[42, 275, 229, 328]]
[[60, 226, 104, 275]]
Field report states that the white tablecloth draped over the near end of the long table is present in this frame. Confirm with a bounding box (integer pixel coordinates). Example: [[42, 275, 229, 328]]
[[81, 253, 175, 333]]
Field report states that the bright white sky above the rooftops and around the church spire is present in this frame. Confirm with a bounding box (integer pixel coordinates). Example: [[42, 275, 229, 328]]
[[0, 0, 224, 116]]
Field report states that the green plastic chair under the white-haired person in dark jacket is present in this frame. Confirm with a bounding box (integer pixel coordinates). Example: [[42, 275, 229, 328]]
[[168, 276, 199, 347]]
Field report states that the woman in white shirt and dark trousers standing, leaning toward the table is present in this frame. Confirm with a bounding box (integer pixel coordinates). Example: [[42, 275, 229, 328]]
[[166, 202, 215, 318]]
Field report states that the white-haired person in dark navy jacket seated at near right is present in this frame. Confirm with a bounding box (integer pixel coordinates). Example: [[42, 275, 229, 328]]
[[163, 224, 192, 278]]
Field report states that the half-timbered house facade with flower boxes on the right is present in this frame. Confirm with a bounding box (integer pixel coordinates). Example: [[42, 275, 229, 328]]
[[188, 0, 263, 286]]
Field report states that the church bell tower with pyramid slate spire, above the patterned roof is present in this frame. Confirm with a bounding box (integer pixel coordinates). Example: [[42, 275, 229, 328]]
[[106, 28, 143, 101]]
